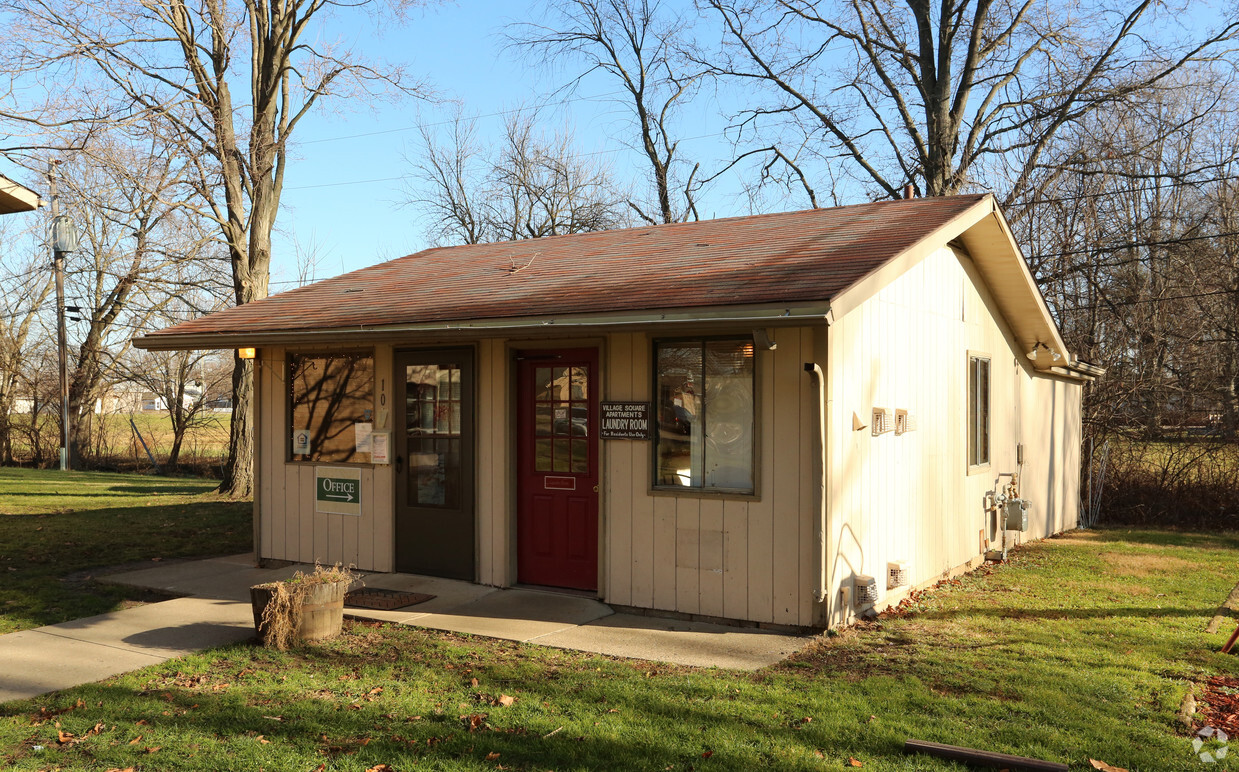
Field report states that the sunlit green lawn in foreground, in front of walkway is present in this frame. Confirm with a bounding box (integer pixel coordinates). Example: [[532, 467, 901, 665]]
[[0, 530, 1239, 772]]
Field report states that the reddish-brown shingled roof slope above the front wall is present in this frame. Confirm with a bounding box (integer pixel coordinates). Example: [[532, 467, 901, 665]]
[[146, 196, 984, 343]]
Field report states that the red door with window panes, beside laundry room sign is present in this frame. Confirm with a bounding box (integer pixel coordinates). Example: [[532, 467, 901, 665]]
[[517, 348, 598, 590]]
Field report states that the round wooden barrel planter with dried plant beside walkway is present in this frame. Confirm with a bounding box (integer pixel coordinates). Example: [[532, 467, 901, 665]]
[[250, 563, 362, 652]]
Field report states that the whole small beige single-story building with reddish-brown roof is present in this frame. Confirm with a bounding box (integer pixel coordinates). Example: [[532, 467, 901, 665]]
[[136, 195, 1100, 628]]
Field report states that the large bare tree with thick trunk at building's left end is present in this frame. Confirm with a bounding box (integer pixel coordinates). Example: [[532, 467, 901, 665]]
[[0, 0, 433, 496]]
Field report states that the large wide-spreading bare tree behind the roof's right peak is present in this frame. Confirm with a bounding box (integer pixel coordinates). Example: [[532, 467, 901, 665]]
[[698, 0, 1239, 200]]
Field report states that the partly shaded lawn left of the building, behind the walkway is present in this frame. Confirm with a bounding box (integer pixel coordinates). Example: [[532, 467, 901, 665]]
[[0, 467, 253, 633]]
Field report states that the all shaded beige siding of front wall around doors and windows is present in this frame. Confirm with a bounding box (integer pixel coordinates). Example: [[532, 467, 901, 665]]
[[256, 328, 825, 626]]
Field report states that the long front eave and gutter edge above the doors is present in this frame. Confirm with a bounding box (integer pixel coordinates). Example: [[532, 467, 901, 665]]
[[134, 301, 831, 351]]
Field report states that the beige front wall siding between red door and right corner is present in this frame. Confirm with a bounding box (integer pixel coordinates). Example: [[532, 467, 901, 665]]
[[602, 326, 825, 626]]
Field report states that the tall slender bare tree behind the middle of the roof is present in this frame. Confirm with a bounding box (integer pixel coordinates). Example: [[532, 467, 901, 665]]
[[509, 0, 701, 223]]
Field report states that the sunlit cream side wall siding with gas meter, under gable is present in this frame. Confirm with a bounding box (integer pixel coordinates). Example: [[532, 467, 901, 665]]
[[826, 248, 1080, 625]]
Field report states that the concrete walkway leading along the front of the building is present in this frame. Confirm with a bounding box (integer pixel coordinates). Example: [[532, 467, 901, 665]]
[[0, 554, 809, 703]]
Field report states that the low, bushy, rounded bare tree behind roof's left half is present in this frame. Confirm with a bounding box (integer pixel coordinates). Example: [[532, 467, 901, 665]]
[[408, 110, 627, 244]]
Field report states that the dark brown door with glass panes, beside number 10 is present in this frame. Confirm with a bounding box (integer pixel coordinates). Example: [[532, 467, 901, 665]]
[[393, 349, 475, 581]]
